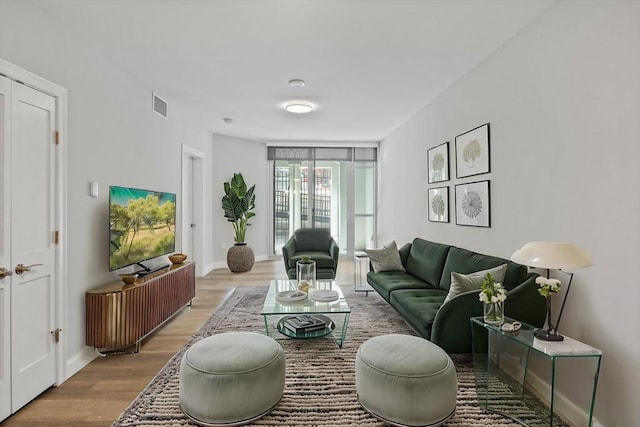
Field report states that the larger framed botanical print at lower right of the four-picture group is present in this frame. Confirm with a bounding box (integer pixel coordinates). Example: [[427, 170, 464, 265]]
[[456, 181, 490, 227]]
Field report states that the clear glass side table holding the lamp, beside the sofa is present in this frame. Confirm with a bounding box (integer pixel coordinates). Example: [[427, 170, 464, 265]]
[[471, 317, 602, 426]]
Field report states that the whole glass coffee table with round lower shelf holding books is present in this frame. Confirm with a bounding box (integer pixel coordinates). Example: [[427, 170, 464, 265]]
[[260, 280, 351, 348]]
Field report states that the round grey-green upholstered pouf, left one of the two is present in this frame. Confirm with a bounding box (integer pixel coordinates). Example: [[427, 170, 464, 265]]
[[180, 332, 285, 425]]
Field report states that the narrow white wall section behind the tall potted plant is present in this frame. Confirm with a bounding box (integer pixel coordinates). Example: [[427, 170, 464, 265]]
[[212, 135, 272, 268]]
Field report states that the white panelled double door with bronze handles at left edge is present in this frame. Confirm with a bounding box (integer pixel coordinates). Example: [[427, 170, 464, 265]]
[[0, 74, 56, 419]]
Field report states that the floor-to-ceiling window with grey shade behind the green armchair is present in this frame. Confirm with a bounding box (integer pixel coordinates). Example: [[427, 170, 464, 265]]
[[268, 147, 377, 254]]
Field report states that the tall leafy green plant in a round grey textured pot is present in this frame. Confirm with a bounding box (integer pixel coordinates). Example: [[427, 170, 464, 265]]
[[222, 173, 256, 273]]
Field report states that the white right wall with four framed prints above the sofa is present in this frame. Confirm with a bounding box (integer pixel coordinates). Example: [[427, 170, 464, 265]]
[[379, 1, 640, 427]]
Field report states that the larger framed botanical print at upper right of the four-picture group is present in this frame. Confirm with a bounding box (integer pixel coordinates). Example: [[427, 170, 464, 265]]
[[456, 123, 490, 178]]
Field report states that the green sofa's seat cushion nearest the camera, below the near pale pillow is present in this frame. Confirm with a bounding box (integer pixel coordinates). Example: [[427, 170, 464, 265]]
[[389, 288, 447, 339]]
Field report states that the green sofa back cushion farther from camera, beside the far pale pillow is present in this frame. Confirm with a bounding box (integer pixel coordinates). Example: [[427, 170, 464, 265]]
[[405, 241, 451, 290]]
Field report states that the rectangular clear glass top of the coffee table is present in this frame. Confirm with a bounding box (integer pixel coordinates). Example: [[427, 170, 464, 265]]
[[260, 279, 351, 315]]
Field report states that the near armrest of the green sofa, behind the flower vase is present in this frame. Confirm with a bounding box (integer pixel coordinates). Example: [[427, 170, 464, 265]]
[[430, 273, 546, 353]]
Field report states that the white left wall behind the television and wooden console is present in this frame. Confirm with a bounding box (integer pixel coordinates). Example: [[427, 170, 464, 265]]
[[0, 1, 218, 377]]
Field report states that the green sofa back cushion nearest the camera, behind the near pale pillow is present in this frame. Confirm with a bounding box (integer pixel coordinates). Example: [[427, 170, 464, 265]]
[[439, 247, 527, 291]]
